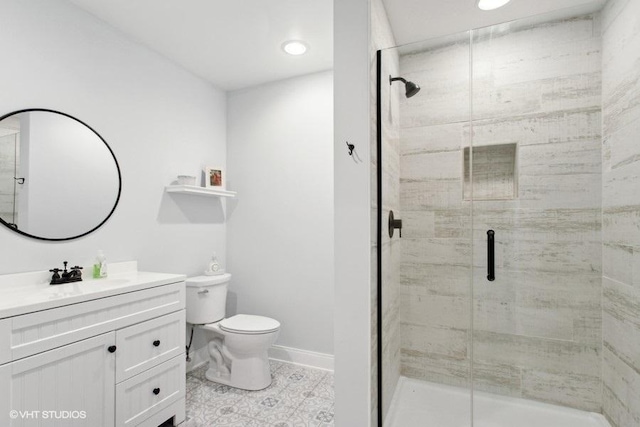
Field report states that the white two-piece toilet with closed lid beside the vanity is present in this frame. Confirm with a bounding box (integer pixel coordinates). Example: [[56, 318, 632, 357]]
[[186, 273, 280, 390]]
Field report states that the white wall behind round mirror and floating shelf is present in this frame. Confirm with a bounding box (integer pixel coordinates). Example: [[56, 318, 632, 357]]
[[0, 0, 226, 274]]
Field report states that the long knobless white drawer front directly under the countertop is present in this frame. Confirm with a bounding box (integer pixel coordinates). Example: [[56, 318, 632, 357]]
[[5, 282, 185, 363]]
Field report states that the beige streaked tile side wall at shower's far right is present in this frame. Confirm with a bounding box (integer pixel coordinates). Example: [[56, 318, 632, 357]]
[[602, 0, 640, 427]]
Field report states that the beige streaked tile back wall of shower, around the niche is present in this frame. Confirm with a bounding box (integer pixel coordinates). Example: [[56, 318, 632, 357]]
[[400, 12, 604, 411]]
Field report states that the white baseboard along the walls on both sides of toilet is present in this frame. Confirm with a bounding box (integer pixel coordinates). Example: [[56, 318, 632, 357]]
[[187, 345, 333, 372]]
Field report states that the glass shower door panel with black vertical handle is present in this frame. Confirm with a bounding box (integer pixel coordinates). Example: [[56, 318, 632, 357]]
[[464, 11, 602, 427]]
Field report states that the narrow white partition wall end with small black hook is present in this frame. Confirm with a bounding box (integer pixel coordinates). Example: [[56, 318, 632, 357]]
[[333, 0, 375, 427]]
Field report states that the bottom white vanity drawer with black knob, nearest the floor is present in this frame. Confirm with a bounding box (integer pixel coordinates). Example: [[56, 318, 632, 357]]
[[116, 354, 186, 427]]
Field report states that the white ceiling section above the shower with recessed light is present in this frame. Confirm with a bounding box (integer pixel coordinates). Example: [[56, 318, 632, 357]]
[[382, 0, 606, 45]]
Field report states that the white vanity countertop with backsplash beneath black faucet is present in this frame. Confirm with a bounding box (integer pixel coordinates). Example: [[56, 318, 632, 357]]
[[0, 261, 186, 319]]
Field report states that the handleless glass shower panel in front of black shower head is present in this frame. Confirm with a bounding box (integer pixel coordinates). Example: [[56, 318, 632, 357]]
[[378, 32, 472, 427]]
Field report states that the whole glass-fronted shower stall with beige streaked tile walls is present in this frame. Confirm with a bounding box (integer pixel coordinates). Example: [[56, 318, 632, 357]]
[[377, 0, 640, 427]]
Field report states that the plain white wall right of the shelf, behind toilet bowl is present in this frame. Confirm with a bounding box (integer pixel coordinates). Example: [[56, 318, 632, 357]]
[[227, 71, 334, 354]]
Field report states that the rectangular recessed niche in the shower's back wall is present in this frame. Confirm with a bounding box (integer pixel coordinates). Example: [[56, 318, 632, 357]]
[[463, 143, 518, 200]]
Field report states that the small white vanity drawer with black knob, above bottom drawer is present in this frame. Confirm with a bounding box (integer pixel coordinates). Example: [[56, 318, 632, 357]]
[[116, 310, 186, 382]]
